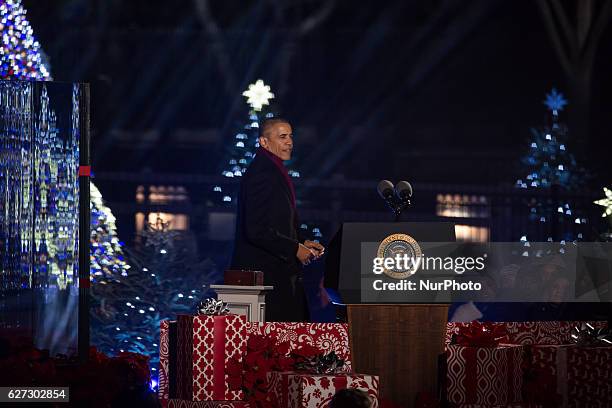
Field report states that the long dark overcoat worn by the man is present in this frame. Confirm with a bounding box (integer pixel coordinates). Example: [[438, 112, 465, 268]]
[[232, 153, 304, 321]]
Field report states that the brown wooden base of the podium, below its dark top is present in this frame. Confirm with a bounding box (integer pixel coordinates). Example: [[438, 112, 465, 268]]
[[347, 304, 448, 407]]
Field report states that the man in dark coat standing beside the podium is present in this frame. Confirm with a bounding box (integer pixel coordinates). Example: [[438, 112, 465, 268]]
[[232, 118, 324, 321]]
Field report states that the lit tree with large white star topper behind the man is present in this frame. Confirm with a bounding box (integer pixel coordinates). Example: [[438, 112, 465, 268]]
[[213, 79, 322, 240]]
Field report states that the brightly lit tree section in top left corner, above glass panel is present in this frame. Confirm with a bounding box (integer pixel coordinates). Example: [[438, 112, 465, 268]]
[[0, 0, 51, 80]]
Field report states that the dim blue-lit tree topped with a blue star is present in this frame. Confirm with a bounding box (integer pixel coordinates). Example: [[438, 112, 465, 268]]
[[516, 88, 587, 243]]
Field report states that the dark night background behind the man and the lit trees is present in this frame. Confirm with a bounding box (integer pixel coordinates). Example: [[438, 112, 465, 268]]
[[24, 0, 612, 258]]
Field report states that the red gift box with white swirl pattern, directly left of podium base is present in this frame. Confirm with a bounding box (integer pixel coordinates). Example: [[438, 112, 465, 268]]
[[247, 322, 351, 372]]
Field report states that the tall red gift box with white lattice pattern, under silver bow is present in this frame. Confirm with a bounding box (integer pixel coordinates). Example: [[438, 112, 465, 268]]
[[176, 315, 247, 401]]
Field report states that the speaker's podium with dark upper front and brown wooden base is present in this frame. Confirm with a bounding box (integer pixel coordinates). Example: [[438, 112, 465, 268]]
[[325, 222, 455, 407]]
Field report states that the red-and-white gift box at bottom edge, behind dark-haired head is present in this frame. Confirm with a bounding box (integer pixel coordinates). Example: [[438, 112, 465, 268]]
[[268, 371, 378, 408]]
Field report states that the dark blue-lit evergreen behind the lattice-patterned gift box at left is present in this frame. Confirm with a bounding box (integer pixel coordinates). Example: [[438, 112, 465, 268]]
[[92, 217, 220, 381]]
